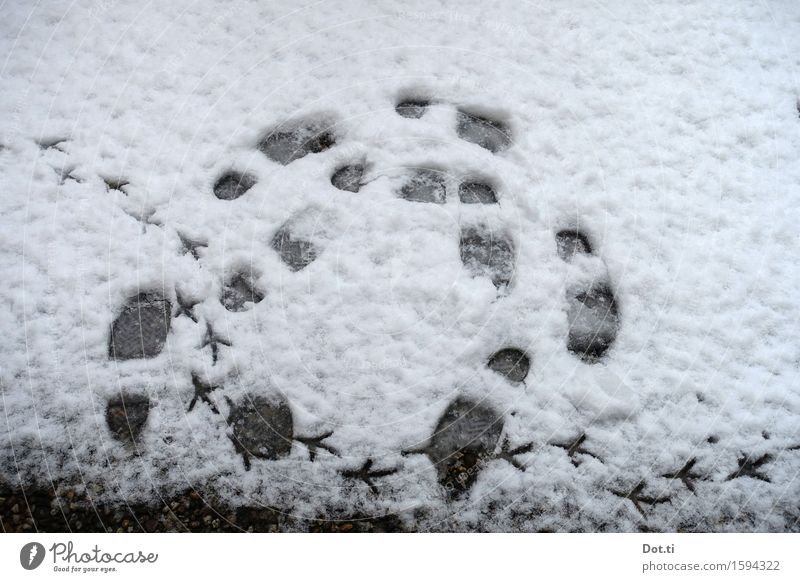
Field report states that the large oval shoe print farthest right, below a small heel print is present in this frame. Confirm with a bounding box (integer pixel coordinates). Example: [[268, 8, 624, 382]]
[[567, 283, 619, 363]]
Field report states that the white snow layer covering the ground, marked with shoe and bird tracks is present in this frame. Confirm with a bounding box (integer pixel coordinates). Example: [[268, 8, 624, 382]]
[[0, 0, 800, 531]]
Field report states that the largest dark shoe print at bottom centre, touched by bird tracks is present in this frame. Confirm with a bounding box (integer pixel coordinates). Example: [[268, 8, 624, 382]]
[[413, 398, 503, 498]]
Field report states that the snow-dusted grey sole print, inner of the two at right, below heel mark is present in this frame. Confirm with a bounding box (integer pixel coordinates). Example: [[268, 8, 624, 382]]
[[459, 226, 515, 288]]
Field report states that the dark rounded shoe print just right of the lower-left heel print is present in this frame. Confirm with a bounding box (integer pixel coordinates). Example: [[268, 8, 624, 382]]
[[228, 394, 294, 469]]
